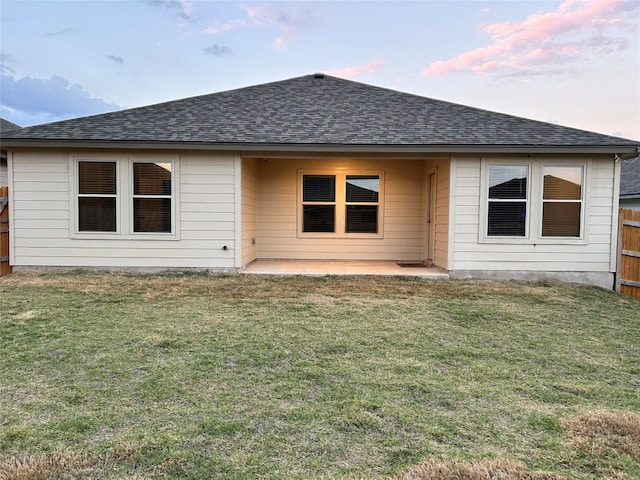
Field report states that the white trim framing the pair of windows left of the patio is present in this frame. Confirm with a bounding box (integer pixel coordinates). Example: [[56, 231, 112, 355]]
[[69, 153, 180, 241]]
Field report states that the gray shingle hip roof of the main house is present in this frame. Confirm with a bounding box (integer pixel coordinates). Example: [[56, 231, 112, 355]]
[[3, 75, 638, 147]]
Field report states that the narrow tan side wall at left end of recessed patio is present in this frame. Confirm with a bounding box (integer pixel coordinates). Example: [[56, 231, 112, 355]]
[[240, 159, 258, 266]]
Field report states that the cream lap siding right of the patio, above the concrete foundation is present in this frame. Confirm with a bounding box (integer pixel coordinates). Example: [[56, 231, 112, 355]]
[[451, 157, 614, 272]]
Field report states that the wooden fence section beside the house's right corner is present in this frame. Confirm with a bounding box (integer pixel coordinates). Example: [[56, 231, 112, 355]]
[[616, 208, 640, 298]]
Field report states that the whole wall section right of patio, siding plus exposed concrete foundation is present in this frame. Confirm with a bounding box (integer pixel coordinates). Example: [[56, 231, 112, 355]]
[[449, 156, 615, 288]]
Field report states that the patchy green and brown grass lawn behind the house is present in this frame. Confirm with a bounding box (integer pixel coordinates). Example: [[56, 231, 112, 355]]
[[0, 272, 640, 480]]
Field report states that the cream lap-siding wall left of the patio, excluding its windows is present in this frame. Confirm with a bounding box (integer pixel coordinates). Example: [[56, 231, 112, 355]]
[[10, 150, 235, 270]]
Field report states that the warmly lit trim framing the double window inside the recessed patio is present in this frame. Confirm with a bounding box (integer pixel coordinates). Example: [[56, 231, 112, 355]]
[[296, 169, 385, 239]]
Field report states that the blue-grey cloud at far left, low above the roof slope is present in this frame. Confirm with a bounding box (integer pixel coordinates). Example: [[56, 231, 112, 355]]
[[0, 75, 121, 118]]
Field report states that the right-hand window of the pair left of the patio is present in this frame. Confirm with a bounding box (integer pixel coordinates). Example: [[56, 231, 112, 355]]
[[133, 162, 172, 233]]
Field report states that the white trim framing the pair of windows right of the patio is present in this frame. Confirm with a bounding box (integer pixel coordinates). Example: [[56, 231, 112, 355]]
[[478, 158, 591, 245]]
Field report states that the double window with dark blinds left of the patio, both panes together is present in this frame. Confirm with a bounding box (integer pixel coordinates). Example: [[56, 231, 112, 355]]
[[70, 155, 177, 238]]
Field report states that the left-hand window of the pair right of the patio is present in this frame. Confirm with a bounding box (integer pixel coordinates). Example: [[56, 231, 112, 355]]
[[487, 165, 529, 237]]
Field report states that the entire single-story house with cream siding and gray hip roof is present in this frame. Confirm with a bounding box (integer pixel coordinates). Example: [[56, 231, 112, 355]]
[[3, 74, 638, 288]]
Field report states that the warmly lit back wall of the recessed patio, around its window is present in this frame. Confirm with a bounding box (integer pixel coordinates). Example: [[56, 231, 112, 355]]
[[257, 159, 426, 261]]
